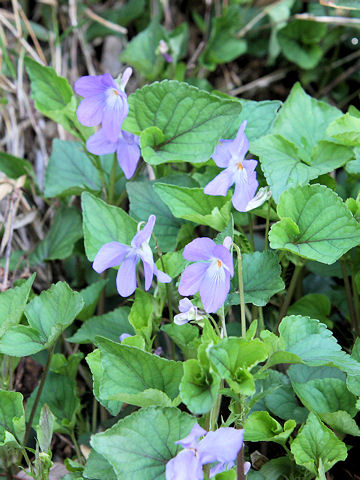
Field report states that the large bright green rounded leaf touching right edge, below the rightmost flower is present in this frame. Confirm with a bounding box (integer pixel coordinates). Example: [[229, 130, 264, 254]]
[[269, 185, 360, 264]]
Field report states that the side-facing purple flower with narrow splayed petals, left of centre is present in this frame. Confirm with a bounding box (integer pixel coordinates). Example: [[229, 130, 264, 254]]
[[93, 215, 171, 297]]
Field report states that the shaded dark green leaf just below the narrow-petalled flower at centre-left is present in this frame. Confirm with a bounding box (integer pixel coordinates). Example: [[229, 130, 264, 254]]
[[66, 307, 134, 343]]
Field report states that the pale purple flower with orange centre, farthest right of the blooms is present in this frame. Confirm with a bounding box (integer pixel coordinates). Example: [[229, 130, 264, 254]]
[[204, 121, 259, 212]]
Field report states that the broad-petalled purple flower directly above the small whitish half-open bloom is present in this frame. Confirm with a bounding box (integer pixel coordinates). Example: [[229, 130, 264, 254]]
[[179, 237, 234, 313]]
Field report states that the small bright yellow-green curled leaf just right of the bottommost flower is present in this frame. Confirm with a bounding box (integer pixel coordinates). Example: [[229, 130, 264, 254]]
[[244, 412, 296, 445]]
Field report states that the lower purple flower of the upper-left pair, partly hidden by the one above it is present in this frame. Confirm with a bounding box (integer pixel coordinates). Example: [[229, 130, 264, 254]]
[[86, 128, 140, 179]]
